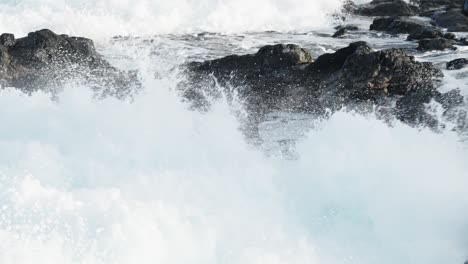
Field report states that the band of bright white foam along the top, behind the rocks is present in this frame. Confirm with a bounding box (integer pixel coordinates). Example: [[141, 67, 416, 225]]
[[0, 0, 341, 39]]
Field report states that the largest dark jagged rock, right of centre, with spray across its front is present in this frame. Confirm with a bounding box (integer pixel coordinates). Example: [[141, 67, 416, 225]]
[[182, 42, 442, 125]]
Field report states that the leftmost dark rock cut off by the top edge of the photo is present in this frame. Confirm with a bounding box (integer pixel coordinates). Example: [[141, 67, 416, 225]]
[[355, 0, 417, 16]]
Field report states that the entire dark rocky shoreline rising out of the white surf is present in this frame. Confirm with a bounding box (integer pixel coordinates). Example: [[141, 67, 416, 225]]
[[0, 0, 468, 131]]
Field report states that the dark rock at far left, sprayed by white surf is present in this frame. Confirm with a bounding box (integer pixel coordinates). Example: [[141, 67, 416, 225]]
[[0, 29, 138, 95]]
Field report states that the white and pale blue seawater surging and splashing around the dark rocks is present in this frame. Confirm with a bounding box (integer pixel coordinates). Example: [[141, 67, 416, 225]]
[[0, 0, 468, 264]]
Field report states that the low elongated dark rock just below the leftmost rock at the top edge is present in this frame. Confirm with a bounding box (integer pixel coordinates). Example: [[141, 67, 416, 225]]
[[370, 17, 436, 36]]
